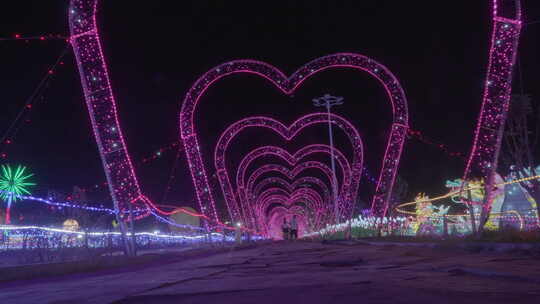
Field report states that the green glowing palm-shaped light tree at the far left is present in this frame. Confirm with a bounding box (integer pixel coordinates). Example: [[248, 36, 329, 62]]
[[0, 165, 36, 224]]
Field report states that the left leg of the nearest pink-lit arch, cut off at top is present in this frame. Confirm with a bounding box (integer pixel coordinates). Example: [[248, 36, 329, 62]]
[[68, 0, 148, 218]]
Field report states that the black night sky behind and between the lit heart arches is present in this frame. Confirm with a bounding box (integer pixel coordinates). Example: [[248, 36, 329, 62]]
[[0, 0, 540, 217]]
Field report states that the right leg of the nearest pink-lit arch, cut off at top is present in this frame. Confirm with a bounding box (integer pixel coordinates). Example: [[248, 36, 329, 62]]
[[463, 0, 522, 209]]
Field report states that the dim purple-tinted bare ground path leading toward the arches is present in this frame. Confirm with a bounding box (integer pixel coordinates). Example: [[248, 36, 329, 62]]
[[0, 242, 540, 304]]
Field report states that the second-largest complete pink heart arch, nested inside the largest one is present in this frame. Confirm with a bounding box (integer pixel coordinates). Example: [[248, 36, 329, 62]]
[[215, 113, 363, 226]]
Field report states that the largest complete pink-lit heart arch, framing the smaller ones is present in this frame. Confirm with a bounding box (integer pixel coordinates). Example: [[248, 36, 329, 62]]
[[180, 53, 408, 218]]
